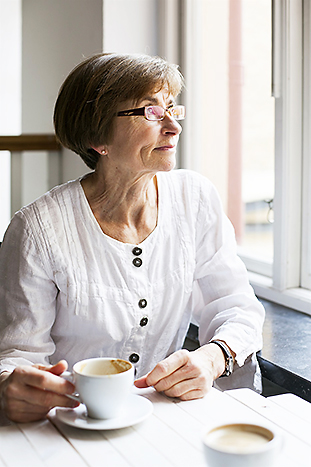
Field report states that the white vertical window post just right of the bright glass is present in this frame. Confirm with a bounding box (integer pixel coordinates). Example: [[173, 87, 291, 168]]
[[272, 0, 303, 291]]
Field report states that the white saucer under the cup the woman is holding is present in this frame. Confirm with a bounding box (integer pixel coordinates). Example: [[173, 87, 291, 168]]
[[55, 394, 153, 430]]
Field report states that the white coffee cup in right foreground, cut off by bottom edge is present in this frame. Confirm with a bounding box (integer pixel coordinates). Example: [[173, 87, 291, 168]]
[[203, 423, 280, 467]]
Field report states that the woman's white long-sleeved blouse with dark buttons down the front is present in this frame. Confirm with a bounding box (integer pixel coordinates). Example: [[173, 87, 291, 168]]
[[0, 170, 264, 389]]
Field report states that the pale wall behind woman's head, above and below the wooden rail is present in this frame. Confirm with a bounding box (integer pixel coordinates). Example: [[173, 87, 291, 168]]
[[0, 0, 166, 231]]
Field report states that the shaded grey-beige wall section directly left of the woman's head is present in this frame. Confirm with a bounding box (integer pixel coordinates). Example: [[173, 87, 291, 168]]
[[22, 0, 103, 188]]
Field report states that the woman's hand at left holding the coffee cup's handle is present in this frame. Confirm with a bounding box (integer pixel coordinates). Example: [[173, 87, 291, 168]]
[[0, 360, 79, 422]]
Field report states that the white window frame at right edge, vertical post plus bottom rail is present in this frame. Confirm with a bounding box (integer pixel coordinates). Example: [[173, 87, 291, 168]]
[[254, 0, 311, 315]]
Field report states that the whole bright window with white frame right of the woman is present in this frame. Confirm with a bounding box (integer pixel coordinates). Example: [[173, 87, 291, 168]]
[[180, 0, 311, 314]]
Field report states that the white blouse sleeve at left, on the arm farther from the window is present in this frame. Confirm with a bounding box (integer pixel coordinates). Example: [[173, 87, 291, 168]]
[[0, 211, 57, 372]]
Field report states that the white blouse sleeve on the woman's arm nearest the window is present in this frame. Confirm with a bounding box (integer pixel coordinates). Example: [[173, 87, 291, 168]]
[[195, 181, 264, 366]]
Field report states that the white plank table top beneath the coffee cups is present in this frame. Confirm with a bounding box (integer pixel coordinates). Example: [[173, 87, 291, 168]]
[[0, 389, 311, 467]]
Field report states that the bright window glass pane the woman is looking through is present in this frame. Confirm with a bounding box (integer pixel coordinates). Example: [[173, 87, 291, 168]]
[[190, 0, 274, 275]]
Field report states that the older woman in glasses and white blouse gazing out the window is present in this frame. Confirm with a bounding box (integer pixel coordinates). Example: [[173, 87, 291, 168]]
[[0, 54, 264, 421]]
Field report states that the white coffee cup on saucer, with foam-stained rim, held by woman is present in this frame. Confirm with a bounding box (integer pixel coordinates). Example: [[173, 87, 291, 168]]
[[64, 357, 134, 419]]
